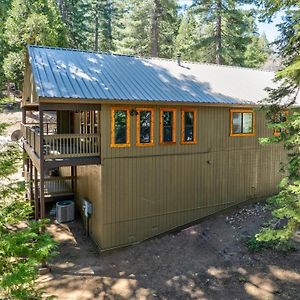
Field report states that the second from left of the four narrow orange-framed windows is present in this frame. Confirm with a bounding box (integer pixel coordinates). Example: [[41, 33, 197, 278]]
[[136, 108, 154, 146]]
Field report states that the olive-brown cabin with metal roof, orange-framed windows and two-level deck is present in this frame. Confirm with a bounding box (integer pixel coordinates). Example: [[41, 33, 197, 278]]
[[21, 46, 286, 250]]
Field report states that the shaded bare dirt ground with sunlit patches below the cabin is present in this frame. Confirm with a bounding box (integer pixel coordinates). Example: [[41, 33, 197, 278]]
[[39, 204, 300, 300]]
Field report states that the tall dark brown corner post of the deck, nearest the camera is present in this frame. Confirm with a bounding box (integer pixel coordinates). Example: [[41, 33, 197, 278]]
[[39, 105, 46, 219]]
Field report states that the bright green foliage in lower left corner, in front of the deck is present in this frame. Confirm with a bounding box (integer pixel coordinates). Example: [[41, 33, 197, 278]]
[[0, 119, 56, 300]]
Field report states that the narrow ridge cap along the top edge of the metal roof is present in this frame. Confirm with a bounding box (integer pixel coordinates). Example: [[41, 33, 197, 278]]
[[28, 45, 274, 73]]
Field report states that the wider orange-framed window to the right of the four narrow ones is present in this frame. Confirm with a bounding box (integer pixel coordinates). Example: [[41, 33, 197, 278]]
[[230, 109, 255, 136]]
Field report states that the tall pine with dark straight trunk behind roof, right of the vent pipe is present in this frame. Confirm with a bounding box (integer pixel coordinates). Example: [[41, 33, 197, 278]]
[[192, 0, 258, 65]]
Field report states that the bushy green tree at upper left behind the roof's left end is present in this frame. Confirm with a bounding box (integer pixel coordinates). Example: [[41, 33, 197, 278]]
[[3, 0, 67, 87]]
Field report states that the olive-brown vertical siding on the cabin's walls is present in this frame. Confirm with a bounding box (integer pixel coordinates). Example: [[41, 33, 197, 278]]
[[77, 105, 285, 249]]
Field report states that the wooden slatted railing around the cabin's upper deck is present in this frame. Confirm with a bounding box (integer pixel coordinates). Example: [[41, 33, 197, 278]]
[[21, 124, 100, 159]]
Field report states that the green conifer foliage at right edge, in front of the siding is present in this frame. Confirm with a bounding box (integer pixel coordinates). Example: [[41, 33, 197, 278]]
[[255, 111, 300, 247]]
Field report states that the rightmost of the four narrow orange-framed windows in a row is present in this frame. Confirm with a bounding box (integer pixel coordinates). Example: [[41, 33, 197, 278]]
[[181, 108, 197, 144]]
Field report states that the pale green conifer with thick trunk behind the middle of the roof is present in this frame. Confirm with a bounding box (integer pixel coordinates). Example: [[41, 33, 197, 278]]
[[116, 0, 178, 57]]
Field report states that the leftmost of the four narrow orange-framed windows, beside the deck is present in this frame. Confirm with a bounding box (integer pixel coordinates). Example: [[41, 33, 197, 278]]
[[111, 107, 130, 147]]
